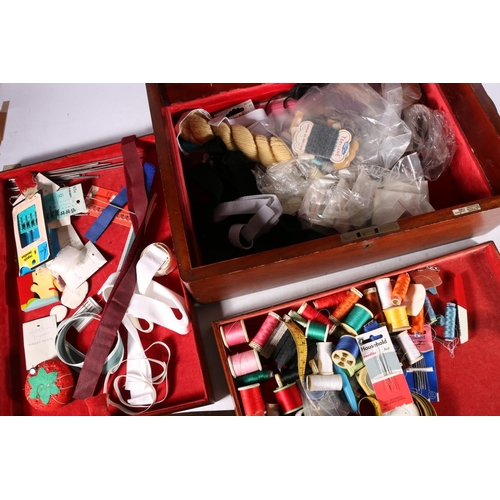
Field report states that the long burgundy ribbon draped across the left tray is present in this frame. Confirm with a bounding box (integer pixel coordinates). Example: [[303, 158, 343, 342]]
[[74, 136, 148, 399]]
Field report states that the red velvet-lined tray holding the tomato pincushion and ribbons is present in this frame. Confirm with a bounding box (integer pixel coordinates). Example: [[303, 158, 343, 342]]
[[0, 135, 212, 415]]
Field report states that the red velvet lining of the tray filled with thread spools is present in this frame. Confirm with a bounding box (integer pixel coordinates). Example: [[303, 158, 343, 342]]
[[214, 242, 500, 416]]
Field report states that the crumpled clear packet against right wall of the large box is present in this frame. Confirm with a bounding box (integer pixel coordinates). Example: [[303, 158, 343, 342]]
[[402, 104, 457, 181]]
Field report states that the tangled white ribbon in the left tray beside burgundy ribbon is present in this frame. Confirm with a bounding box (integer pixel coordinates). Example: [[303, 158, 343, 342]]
[[99, 244, 190, 409]]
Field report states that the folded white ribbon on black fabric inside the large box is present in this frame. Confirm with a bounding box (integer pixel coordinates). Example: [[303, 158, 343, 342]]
[[213, 194, 283, 250]]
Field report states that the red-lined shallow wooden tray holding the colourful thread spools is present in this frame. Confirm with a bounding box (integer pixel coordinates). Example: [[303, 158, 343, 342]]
[[213, 242, 500, 416]]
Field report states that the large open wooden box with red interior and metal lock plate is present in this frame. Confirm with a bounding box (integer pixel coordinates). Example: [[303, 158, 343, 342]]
[[147, 83, 500, 303]]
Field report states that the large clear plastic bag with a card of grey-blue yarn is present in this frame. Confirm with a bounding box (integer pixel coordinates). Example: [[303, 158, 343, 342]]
[[263, 83, 411, 173]]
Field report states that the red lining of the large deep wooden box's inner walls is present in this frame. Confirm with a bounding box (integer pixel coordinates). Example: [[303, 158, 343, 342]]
[[163, 83, 492, 268]]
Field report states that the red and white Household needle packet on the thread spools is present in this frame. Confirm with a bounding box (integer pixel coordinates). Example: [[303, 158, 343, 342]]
[[356, 326, 413, 413]]
